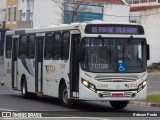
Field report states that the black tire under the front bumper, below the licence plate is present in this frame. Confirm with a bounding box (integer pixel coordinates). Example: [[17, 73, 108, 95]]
[[110, 101, 129, 109]]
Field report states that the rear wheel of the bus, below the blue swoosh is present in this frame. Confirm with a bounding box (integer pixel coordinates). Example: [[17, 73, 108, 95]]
[[21, 78, 29, 99]]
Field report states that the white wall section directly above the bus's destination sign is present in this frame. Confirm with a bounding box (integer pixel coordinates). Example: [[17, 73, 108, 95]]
[[103, 4, 130, 22]]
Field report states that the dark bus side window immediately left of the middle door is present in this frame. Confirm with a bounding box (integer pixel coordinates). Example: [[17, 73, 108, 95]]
[[27, 35, 35, 59]]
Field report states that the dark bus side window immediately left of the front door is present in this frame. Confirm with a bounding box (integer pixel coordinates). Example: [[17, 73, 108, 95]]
[[61, 31, 70, 60]]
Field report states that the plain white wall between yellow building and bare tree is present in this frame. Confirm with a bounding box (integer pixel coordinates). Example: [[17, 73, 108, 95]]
[[33, 0, 63, 27]]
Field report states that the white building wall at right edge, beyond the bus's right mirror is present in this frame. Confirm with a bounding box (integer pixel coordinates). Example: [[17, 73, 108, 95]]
[[141, 8, 160, 64]]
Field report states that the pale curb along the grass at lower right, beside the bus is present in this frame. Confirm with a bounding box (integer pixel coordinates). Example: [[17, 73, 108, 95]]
[[129, 101, 160, 107]]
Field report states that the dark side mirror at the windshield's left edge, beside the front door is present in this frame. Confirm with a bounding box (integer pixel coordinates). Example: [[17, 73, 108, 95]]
[[75, 44, 83, 61]]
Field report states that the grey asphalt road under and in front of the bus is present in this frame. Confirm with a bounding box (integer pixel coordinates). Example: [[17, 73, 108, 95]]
[[0, 86, 160, 120]]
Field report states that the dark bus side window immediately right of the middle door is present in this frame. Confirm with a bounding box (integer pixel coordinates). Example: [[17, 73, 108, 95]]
[[44, 33, 53, 60]]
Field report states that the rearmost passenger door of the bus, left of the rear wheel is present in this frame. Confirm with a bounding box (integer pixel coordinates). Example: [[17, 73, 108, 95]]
[[11, 36, 19, 89]]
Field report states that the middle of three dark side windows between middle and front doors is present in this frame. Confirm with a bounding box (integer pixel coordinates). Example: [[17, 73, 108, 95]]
[[53, 32, 62, 60]]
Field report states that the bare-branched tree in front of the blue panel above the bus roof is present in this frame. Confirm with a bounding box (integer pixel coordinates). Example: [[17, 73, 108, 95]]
[[52, 0, 103, 24]]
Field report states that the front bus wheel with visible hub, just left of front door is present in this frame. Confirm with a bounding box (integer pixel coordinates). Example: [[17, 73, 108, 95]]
[[60, 84, 73, 107]]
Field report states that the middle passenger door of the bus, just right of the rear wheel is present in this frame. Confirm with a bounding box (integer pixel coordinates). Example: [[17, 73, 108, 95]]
[[35, 33, 44, 93]]
